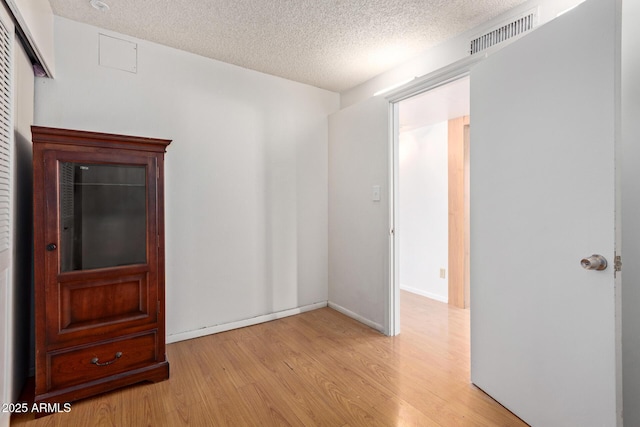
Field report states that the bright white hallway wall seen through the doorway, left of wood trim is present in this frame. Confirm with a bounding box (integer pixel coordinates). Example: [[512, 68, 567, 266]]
[[397, 123, 449, 302]]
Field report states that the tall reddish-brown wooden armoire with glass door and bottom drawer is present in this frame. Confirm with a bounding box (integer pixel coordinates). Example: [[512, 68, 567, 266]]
[[32, 126, 171, 412]]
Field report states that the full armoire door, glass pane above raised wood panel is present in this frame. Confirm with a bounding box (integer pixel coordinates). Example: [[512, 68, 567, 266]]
[[44, 151, 159, 346]]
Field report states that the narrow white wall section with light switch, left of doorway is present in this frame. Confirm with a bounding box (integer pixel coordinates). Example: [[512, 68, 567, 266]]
[[329, 98, 390, 333]]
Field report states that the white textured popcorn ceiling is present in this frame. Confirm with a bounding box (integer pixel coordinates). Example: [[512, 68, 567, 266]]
[[49, 0, 524, 92]]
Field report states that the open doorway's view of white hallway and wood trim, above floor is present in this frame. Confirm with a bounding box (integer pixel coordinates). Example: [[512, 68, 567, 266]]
[[394, 76, 470, 324]]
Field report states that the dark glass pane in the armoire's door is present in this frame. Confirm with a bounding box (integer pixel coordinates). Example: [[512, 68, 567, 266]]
[[58, 161, 147, 272]]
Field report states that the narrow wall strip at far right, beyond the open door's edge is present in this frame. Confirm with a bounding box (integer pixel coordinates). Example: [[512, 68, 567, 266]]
[[621, 0, 640, 426]]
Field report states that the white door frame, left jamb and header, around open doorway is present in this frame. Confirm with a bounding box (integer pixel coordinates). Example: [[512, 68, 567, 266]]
[[384, 53, 484, 336]]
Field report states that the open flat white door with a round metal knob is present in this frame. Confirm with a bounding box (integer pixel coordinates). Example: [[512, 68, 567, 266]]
[[471, 0, 621, 427]]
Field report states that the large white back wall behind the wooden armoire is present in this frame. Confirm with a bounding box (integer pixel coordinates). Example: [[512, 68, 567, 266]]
[[35, 17, 339, 342]]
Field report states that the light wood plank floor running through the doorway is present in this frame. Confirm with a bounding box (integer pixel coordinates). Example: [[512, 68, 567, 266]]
[[11, 292, 526, 427]]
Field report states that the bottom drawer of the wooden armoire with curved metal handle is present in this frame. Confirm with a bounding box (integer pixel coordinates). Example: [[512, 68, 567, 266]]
[[47, 330, 158, 391]]
